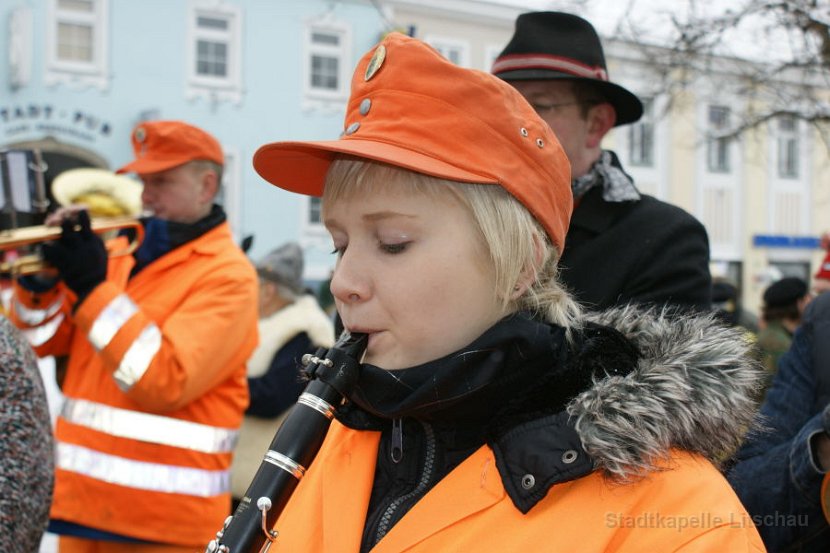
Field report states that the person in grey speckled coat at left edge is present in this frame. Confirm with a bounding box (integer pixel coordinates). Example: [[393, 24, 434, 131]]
[[0, 315, 55, 553]]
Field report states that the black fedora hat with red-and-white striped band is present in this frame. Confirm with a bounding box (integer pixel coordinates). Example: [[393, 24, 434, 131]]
[[492, 12, 643, 125]]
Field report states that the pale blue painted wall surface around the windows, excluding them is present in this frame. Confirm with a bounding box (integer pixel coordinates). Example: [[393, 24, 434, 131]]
[[0, 0, 382, 278]]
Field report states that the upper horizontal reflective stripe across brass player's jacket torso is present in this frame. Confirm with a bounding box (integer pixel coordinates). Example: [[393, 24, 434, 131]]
[[61, 398, 239, 453]]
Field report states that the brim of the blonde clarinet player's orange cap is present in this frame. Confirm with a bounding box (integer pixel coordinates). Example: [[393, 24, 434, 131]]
[[253, 138, 498, 196]]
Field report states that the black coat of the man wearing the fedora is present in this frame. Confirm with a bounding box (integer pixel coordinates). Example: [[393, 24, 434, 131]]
[[559, 186, 712, 310]]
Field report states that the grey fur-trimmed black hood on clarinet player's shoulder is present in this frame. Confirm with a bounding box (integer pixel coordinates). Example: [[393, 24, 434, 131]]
[[488, 306, 764, 512]]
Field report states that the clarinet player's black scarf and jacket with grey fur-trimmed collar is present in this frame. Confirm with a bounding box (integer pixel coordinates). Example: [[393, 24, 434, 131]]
[[336, 307, 762, 551]]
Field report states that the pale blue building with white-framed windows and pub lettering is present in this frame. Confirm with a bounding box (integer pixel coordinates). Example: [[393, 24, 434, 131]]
[[0, 0, 384, 279]]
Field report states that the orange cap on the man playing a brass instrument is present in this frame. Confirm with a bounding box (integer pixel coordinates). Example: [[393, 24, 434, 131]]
[[116, 121, 225, 174]]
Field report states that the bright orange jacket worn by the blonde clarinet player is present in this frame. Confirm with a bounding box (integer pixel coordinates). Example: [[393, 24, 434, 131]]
[[275, 422, 764, 553]]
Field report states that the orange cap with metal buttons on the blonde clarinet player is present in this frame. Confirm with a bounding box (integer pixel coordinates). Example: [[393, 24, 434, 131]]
[[254, 33, 573, 252]]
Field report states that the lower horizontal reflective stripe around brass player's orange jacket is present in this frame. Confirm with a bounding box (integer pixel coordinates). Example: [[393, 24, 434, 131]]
[[55, 442, 231, 496]]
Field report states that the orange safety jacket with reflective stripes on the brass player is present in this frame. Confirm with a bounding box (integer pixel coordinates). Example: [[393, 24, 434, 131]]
[[12, 223, 257, 550]]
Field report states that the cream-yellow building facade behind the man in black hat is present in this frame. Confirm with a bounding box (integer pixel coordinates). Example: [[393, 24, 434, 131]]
[[385, 0, 830, 314]]
